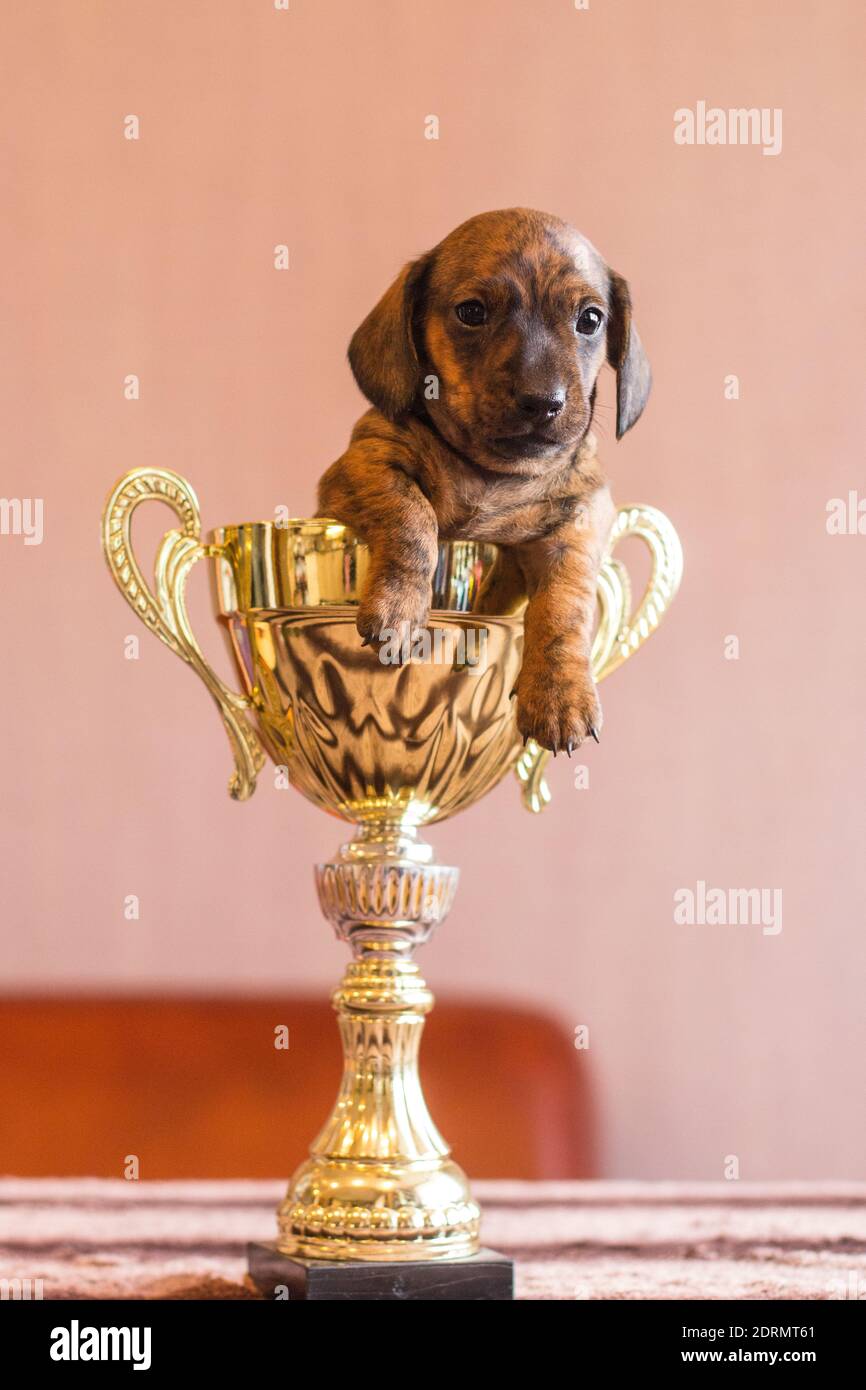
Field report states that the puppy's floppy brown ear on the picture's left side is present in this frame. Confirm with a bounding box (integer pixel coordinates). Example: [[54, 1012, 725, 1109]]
[[349, 253, 431, 420]]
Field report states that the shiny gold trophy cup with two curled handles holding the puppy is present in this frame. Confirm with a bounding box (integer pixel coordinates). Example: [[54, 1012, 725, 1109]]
[[103, 468, 683, 1298]]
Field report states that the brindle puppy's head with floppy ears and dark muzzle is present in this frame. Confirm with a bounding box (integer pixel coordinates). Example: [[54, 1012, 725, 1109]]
[[349, 209, 651, 474]]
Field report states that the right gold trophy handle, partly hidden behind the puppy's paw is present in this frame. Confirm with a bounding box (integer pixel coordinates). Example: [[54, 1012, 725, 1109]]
[[514, 505, 683, 812]]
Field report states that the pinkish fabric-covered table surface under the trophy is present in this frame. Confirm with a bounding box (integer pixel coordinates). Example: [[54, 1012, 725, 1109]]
[[0, 1179, 866, 1300]]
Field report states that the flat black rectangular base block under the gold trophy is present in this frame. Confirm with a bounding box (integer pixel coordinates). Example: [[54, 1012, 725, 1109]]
[[246, 1241, 514, 1302]]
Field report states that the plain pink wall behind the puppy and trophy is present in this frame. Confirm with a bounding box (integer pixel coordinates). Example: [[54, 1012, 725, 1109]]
[[0, 0, 866, 1177]]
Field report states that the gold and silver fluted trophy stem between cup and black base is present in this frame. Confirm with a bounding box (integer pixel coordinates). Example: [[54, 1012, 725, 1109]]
[[278, 831, 480, 1261]]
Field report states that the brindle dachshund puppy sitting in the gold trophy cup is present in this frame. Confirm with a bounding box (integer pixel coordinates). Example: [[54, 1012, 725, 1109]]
[[318, 209, 651, 753]]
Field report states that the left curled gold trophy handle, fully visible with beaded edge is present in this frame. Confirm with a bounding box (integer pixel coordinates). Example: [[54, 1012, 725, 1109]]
[[103, 468, 264, 801]]
